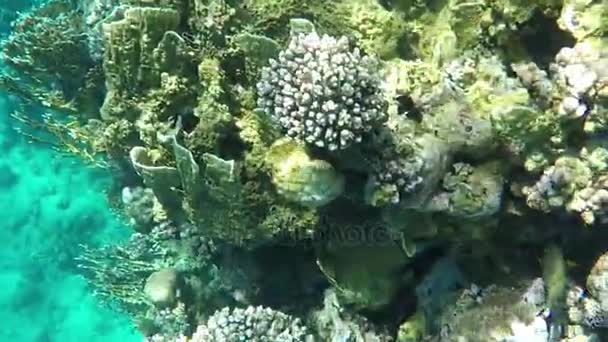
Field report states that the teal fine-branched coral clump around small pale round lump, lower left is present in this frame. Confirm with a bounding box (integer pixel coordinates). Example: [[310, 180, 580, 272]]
[[78, 223, 218, 336]]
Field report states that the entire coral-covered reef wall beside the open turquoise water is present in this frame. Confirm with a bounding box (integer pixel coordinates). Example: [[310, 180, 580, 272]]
[[0, 0, 608, 342]]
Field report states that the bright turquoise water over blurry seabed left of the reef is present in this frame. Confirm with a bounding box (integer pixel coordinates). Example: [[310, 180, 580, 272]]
[[0, 93, 141, 342]]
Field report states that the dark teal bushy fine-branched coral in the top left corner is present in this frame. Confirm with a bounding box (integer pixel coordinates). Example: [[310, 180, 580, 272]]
[[0, 0, 103, 117]]
